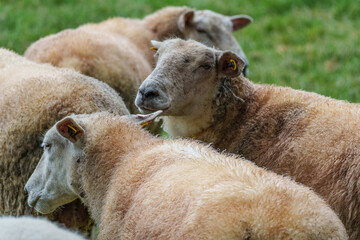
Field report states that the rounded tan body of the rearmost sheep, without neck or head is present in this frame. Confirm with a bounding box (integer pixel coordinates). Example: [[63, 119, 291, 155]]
[[25, 29, 152, 111]]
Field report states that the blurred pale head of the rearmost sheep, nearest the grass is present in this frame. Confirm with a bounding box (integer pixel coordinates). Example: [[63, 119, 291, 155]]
[[178, 10, 252, 76]]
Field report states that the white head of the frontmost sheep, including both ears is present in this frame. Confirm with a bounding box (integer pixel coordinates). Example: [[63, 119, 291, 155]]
[[25, 111, 162, 214]]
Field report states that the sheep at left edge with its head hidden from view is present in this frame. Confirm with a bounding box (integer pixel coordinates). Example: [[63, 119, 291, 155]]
[[0, 48, 129, 234]]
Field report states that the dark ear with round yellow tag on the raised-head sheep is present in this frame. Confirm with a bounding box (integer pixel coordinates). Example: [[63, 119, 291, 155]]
[[217, 51, 245, 77]]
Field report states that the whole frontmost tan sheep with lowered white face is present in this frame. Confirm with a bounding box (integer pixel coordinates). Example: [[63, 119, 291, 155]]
[[25, 111, 347, 240]]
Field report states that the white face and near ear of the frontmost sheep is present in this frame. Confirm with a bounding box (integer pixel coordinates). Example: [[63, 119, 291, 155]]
[[25, 119, 83, 214]]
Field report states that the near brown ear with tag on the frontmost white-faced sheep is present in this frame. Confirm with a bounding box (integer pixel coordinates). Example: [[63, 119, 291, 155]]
[[56, 117, 85, 143]]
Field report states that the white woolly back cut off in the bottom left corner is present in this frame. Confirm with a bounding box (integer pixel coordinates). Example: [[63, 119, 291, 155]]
[[0, 216, 85, 240]]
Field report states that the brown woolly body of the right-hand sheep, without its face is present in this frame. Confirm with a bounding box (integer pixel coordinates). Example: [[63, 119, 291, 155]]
[[164, 71, 360, 240]]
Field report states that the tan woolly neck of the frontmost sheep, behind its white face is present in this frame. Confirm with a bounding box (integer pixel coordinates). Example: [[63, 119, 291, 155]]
[[78, 124, 160, 224]]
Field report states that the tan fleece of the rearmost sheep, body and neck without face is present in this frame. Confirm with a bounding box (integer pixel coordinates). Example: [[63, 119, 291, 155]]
[[25, 7, 189, 112]]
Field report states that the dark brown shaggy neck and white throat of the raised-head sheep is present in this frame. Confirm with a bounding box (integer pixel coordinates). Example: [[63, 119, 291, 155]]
[[164, 77, 255, 143]]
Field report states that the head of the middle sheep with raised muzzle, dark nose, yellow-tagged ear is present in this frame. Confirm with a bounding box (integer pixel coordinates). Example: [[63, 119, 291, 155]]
[[135, 39, 244, 117]]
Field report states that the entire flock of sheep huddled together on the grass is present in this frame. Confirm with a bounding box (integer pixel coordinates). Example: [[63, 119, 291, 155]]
[[0, 7, 360, 240]]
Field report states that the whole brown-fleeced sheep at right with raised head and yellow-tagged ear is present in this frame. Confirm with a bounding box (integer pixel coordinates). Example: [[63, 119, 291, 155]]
[[136, 39, 360, 239]]
